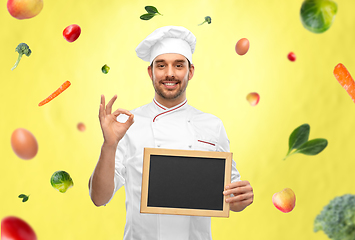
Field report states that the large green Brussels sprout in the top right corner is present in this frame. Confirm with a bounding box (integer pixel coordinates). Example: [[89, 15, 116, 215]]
[[300, 0, 338, 33]]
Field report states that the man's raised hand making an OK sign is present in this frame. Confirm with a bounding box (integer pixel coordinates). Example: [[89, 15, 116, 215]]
[[99, 95, 134, 147]]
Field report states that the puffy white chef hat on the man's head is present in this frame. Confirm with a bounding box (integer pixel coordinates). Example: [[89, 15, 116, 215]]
[[136, 26, 196, 63]]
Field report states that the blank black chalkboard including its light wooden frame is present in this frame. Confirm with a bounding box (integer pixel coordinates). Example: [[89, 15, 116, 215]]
[[141, 148, 232, 217]]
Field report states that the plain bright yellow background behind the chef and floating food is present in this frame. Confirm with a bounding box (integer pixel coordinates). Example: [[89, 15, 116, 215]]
[[0, 0, 355, 240]]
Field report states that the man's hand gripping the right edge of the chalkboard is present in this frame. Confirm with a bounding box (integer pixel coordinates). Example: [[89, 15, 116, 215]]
[[223, 181, 254, 212]]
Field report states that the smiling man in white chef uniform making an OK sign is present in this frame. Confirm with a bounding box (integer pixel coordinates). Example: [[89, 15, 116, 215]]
[[89, 26, 254, 240]]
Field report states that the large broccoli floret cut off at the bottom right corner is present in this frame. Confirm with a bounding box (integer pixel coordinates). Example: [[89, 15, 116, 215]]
[[314, 194, 355, 240]]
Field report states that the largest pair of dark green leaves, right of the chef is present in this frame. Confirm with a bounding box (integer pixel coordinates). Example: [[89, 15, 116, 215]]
[[283, 123, 328, 160]]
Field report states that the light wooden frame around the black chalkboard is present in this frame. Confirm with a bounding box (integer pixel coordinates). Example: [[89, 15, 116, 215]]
[[140, 148, 232, 218]]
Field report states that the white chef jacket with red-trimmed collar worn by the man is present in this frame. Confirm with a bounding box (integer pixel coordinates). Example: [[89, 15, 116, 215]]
[[90, 99, 240, 240]]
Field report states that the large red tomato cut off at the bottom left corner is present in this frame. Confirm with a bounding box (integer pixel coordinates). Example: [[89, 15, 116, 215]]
[[1, 216, 37, 240]]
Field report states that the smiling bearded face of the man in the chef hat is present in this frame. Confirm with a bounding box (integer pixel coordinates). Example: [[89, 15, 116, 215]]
[[148, 53, 194, 100]]
